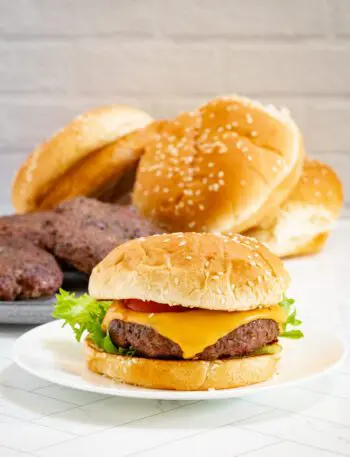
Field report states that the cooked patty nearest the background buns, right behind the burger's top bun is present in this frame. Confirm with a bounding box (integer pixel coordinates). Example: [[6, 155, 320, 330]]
[[54, 197, 162, 274]]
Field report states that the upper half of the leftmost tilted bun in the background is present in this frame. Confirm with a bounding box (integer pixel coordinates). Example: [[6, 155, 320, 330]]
[[12, 105, 151, 213]]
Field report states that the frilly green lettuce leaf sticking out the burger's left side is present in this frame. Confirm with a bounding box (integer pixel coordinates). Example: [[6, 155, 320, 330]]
[[52, 289, 136, 356]]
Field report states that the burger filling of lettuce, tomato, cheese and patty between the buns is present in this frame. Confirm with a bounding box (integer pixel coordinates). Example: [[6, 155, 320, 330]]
[[53, 290, 303, 360]]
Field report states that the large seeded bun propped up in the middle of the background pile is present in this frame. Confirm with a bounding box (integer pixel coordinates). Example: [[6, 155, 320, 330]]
[[133, 96, 303, 232]]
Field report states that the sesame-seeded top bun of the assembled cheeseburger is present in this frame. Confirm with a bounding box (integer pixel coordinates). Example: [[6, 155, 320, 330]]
[[89, 233, 289, 311]]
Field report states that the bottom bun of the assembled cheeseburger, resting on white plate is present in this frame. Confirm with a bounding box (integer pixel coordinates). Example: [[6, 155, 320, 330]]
[[85, 340, 279, 390]]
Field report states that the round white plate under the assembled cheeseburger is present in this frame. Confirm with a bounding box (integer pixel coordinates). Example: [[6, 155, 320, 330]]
[[13, 321, 346, 400]]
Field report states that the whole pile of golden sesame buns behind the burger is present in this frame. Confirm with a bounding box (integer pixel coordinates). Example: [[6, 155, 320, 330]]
[[12, 96, 343, 257]]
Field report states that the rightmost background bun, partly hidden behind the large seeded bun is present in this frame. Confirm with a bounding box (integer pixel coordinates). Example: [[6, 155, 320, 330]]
[[247, 159, 343, 257]]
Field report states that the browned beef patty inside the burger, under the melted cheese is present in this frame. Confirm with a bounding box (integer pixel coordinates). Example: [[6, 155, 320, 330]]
[[109, 319, 279, 360]]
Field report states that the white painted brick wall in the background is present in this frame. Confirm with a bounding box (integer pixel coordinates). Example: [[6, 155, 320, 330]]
[[0, 0, 350, 216]]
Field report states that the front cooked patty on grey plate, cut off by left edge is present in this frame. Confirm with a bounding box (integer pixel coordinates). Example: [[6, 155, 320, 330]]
[[0, 235, 63, 300]]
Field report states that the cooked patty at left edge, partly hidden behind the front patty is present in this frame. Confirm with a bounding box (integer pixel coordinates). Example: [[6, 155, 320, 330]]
[[0, 212, 56, 250]]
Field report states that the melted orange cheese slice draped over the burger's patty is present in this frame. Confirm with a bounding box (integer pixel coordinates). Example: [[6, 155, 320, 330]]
[[102, 302, 287, 359]]
